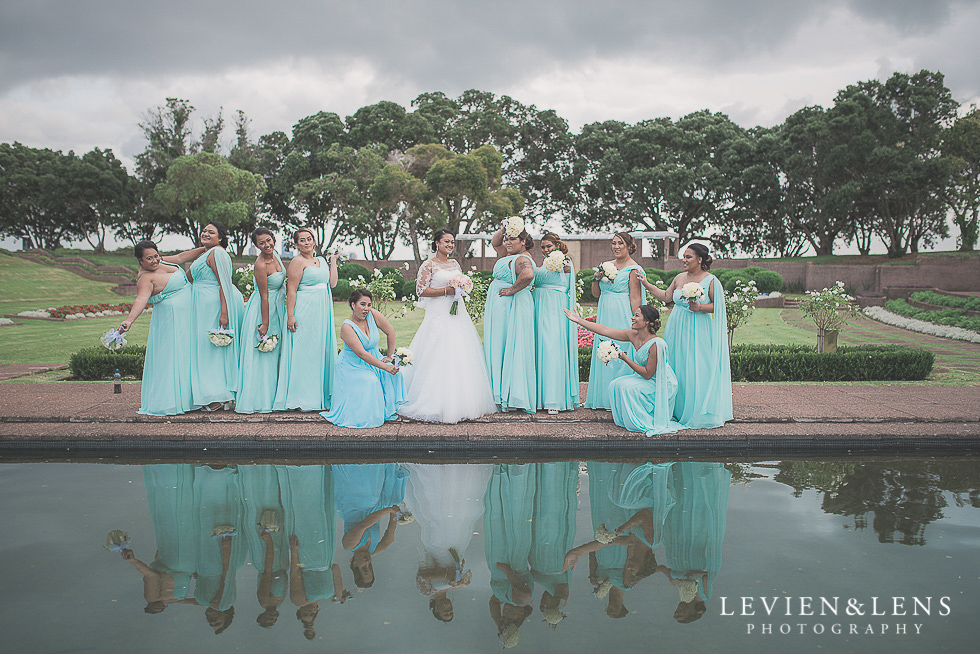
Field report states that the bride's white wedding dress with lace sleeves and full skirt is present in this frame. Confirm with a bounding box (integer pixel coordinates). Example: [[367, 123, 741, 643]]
[[398, 259, 497, 423]]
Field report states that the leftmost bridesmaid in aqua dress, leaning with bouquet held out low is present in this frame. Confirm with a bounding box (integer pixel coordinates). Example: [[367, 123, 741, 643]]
[[119, 241, 204, 416]]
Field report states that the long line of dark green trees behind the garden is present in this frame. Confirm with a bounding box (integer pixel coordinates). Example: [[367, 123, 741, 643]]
[[0, 70, 980, 260]]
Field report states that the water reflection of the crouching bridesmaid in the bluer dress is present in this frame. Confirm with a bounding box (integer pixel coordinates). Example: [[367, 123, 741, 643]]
[[333, 463, 408, 588]]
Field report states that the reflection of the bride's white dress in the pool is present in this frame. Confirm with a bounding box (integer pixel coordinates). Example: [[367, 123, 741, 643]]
[[403, 463, 493, 576]]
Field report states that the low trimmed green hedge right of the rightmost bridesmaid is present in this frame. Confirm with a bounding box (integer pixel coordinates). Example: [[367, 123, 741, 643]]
[[731, 345, 935, 382]]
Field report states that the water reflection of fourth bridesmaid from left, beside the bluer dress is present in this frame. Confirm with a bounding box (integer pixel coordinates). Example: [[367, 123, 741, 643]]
[[279, 466, 344, 640]]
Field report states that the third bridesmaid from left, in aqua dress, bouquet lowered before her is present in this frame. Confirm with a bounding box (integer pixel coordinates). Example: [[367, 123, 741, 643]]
[[235, 227, 286, 413]]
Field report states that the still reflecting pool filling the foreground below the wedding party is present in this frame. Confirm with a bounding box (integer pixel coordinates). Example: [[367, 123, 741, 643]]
[[0, 458, 980, 653]]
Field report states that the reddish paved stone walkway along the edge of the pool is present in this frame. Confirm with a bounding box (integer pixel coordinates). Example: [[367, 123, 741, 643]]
[[0, 382, 980, 455]]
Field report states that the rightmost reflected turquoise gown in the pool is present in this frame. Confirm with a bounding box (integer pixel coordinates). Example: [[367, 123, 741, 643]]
[[663, 461, 732, 601]]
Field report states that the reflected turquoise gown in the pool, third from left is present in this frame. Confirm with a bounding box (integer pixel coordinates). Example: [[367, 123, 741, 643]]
[[238, 465, 289, 597]]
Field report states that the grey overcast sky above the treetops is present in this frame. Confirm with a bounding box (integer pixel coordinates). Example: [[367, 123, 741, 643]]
[[0, 0, 980, 254]]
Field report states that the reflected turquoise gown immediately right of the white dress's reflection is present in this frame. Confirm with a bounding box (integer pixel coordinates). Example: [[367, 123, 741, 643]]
[[483, 464, 537, 606]]
